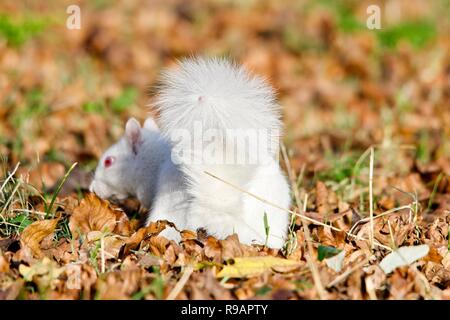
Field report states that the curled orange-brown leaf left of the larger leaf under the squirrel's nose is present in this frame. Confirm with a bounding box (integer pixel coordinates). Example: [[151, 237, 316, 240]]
[[20, 219, 58, 257]]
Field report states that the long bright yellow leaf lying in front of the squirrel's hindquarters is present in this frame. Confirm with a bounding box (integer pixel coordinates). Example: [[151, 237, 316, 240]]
[[216, 256, 300, 278]]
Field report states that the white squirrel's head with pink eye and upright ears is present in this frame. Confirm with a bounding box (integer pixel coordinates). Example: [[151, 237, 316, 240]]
[[89, 118, 159, 200]]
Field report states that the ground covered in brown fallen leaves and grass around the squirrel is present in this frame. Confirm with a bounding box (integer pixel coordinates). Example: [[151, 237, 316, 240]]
[[0, 0, 450, 299]]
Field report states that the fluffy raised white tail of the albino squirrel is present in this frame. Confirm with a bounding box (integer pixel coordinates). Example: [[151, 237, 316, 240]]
[[155, 58, 281, 218]]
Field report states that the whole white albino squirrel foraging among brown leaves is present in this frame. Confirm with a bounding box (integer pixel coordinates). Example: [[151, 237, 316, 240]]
[[90, 58, 291, 248]]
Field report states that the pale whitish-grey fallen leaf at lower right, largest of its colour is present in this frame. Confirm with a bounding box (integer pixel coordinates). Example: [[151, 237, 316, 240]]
[[380, 244, 430, 274]]
